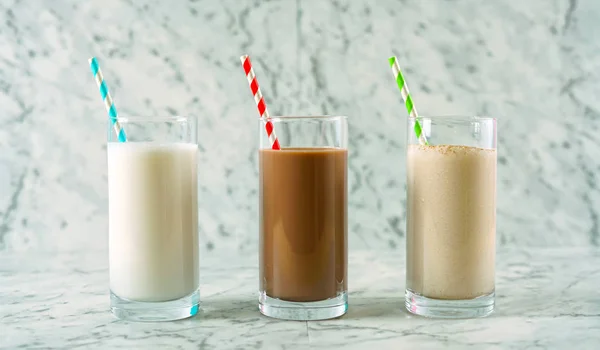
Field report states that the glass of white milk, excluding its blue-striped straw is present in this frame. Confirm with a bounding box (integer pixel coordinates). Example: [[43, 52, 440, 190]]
[[107, 117, 200, 321]]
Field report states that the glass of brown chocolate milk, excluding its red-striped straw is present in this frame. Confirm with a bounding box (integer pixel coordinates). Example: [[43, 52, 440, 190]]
[[259, 116, 348, 320]]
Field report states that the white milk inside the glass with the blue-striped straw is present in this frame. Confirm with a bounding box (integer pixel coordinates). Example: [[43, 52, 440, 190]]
[[107, 142, 199, 301]]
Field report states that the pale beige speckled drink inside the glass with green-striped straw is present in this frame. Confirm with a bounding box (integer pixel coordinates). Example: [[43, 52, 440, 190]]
[[406, 145, 496, 300]]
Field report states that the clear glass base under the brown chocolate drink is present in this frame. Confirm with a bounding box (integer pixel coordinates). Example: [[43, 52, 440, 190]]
[[258, 292, 348, 321]]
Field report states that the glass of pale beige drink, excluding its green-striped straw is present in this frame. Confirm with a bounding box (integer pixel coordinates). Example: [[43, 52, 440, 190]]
[[405, 117, 497, 318]]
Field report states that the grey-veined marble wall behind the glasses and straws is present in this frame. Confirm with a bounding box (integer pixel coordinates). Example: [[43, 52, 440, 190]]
[[0, 0, 600, 253]]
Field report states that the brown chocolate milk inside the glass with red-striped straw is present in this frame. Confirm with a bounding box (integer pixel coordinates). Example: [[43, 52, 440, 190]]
[[259, 148, 348, 302]]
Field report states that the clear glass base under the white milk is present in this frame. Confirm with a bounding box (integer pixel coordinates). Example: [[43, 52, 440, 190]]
[[110, 289, 200, 322]]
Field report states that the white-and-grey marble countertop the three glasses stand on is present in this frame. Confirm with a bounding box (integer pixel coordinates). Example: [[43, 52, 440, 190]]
[[0, 247, 600, 349]]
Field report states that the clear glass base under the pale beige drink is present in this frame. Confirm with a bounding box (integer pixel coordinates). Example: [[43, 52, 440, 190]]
[[404, 289, 495, 318]]
